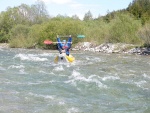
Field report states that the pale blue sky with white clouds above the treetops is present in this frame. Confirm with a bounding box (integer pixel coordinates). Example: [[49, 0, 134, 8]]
[[0, 0, 133, 19]]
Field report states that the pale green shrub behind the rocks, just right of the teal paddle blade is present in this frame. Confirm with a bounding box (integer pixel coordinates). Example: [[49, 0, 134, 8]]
[[83, 19, 109, 44]]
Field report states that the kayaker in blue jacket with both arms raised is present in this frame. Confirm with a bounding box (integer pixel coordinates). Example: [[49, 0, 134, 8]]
[[57, 35, 72, 56]]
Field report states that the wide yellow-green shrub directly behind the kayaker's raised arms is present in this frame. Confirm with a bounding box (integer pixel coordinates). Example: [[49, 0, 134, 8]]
[[41, 18, 83, 43]]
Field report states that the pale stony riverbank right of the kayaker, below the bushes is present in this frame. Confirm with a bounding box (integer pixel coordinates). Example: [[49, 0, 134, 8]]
[[72, 42, 150, 55]]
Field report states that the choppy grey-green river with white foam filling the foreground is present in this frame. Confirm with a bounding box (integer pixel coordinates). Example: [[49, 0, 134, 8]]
[[0, 48, 150, 113]]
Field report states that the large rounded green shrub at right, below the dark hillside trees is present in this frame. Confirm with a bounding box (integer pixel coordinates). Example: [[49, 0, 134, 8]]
[[108, 14, 141, 44]]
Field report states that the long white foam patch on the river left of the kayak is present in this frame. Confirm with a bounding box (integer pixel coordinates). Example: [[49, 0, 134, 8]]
[[14, 54, 48, 61]]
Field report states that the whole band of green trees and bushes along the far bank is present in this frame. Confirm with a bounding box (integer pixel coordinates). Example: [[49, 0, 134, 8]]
[[0, 0, 150, 48]]
